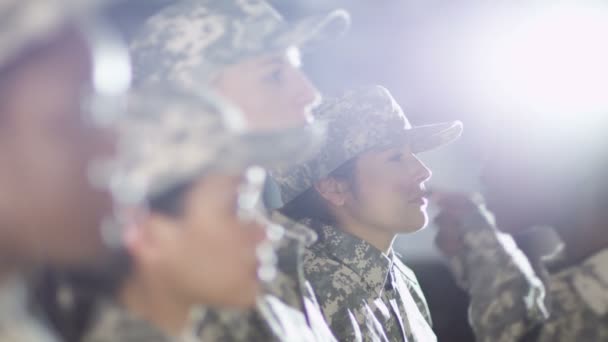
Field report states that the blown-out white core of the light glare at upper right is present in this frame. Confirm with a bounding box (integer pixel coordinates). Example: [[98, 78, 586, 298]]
[[481, 3, 608, 113]]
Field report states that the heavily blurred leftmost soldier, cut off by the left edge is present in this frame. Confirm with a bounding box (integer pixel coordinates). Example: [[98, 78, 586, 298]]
[[0, 0, 130, 342]]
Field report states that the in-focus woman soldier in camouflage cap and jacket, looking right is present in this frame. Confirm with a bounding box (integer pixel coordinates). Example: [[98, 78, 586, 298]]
[[273, 86, 462, 341]]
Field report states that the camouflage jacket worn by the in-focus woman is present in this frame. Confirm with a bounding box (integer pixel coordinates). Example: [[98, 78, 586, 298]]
[[304, 222, 436, 341]]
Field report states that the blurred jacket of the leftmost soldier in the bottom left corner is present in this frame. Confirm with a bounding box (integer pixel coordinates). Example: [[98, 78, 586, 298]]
[[0, 278, 58, 342]]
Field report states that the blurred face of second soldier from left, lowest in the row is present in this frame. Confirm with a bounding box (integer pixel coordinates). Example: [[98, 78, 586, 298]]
[[147, 174, 266, 308]]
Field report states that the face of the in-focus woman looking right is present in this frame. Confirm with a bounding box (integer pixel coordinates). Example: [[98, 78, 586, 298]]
[[344, 146, 431, 233]]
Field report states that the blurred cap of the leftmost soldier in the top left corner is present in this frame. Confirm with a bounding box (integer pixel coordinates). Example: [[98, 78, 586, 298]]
[[0, 0, 108, 66]]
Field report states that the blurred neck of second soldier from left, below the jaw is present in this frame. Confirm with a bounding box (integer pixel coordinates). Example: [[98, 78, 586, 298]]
[[120, 272, 191, 336]]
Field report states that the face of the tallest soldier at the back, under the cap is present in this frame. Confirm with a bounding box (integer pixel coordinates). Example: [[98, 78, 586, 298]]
[[214, 48, 319, 130]]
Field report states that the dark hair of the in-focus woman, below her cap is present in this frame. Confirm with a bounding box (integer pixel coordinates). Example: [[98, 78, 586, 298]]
[[279, 158, 357, 230]]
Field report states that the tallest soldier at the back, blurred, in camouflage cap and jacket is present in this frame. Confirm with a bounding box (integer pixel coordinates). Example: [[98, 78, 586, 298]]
[[132, 0, 348, 341]]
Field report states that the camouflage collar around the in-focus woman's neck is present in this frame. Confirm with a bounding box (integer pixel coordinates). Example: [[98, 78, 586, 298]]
[[319, 225, 394, 294]]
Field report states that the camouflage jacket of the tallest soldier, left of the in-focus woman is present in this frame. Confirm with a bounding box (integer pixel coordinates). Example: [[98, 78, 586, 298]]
[[198, 213, 335, 342]]
